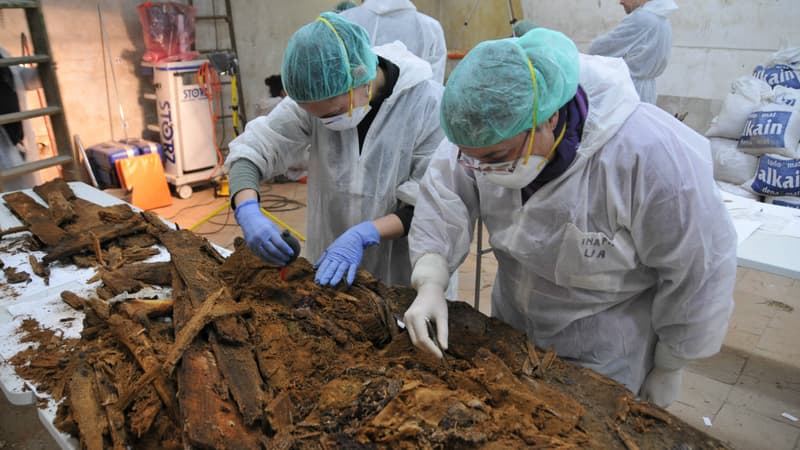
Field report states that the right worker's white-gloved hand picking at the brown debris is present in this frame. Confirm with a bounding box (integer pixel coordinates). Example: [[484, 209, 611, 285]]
[[403, 253, 449, 358]]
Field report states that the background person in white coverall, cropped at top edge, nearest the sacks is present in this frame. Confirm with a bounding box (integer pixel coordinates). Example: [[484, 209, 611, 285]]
[[589, 0, 678, 104]]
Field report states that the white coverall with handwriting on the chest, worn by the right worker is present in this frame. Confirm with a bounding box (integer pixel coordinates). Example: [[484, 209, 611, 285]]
[[409, 55, 736, 392]]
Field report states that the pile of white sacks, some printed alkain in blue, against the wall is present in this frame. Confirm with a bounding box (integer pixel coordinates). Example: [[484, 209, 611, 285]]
[[706, 49, 800, 208]]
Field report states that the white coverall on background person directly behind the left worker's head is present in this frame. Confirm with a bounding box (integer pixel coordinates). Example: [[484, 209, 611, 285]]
[[340, 0, 447, 83]]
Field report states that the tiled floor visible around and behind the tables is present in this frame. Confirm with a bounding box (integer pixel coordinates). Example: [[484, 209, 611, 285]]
[[0, 183, 800, 450]]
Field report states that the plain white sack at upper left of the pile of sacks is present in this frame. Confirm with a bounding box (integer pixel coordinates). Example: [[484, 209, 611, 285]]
[[706, 76, 772, 139]]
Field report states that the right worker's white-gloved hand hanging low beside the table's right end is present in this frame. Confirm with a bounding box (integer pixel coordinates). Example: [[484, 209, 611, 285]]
[[639, 342, 689, 408]]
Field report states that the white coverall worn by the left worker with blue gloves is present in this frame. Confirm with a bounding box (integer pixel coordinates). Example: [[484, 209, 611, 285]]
[[226, 42, 444, 285]]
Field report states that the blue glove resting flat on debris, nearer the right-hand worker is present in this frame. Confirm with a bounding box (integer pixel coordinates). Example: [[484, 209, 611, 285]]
[[314, 221, 381, 286]]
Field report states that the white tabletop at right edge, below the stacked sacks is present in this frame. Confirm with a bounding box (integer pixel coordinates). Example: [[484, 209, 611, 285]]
[[721, 192, 800, 279]]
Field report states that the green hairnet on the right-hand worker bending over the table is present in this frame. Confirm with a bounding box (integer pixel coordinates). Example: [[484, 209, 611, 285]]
[[440, 28, 578, 148]]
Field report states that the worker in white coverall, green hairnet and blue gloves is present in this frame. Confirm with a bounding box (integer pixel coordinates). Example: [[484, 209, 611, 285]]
[[226, 13, 444, 285]]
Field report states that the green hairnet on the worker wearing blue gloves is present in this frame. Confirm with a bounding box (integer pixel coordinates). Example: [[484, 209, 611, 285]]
[[281, 12, 378, 103]]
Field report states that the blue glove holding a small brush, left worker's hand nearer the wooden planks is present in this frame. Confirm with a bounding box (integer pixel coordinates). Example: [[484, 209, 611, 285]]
[[234, 199, 294, 266]]
